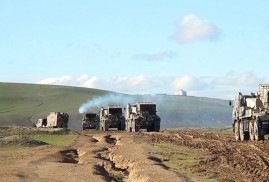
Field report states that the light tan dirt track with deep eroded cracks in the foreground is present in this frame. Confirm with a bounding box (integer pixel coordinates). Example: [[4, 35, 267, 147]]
[[0, 132, 188, 182]]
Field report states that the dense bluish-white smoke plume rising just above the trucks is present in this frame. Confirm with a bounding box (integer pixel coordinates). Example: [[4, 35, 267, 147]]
[[78, 93, 136, 113]]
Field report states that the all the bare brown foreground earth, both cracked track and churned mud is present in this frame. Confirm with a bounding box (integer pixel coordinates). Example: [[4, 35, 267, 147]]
[[0, 129, 269, 182]]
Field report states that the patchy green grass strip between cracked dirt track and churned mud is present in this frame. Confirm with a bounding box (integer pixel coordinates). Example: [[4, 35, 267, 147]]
[[154, 143, 215, 182]]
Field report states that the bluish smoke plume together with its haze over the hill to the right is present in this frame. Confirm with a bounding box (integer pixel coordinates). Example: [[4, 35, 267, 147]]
[[79, 93, 231, 128]]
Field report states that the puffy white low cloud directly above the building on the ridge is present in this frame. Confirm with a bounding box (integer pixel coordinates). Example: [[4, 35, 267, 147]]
[[172, 75, 209, 91]]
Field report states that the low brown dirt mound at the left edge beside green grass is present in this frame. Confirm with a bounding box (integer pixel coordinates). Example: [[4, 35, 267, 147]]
[[0, 135, 47, 147]]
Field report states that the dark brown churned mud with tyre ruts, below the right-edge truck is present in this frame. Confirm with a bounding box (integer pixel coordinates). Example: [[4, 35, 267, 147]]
[[139, 129, 269, 181]]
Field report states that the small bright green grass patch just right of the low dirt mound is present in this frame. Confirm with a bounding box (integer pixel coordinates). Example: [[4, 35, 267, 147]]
[[31, 135, 76, 146]]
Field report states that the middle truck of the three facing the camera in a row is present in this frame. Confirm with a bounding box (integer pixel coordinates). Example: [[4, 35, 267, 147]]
[[99, 105, 125, 131]]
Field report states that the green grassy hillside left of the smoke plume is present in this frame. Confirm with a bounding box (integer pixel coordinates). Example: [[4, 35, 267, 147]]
[[0, 83, 107, 128]]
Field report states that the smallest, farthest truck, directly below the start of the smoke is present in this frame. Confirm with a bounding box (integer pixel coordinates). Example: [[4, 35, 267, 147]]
[[82, 113, 99, 130]]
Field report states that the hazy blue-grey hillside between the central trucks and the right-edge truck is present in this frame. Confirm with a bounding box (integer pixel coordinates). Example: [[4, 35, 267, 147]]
[[156, 96, 232, 128]]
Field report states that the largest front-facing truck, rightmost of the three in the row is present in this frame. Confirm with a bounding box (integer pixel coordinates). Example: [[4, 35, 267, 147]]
[[125, 102, 161, 132]]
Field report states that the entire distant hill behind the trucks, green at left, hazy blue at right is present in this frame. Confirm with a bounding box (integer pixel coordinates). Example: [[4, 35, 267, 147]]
[[0, 83, 231, 129]]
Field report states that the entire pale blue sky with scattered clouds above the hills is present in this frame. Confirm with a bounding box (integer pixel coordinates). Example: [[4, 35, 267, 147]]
[[0, 0, 269, 99]]
